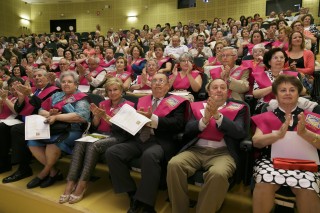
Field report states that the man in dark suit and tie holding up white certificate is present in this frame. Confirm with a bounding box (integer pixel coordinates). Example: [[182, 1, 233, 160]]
[[106, 73, 187, 213]]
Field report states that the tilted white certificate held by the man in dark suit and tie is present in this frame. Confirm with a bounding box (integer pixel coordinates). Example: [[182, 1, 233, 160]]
[[110, 104, 151, 135]]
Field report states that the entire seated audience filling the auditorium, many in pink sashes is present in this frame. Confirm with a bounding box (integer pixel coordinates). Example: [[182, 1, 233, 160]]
[[0, 8, 320, 213]]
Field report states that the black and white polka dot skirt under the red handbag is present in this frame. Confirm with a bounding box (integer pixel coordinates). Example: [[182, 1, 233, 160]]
[[253, 158, 320, 197]]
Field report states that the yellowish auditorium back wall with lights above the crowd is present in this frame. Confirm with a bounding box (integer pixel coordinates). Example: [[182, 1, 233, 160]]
[[0, 0, 320, 35]]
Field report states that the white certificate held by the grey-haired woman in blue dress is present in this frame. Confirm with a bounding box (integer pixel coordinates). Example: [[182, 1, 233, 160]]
[[25, 115, 50, 140]]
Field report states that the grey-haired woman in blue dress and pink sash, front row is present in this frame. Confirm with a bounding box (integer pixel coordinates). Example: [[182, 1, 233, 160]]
[[27, 71, 90, 188]]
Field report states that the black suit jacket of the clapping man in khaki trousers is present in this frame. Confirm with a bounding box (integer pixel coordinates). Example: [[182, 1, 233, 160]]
[[180, 100, 247, 165]]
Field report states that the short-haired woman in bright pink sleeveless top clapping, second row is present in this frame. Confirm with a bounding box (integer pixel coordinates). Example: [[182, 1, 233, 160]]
[[169, 53, 202, 101]]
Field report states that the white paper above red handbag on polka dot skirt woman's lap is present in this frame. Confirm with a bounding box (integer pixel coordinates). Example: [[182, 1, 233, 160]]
[[271, 131, 320, 165]]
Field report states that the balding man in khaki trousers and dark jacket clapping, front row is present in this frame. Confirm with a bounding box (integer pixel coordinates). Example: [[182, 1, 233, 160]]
[[167, 79, 246, 213]]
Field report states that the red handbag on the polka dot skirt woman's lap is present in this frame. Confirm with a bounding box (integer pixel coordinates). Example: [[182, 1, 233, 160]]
[[273, 158, 318, 172]]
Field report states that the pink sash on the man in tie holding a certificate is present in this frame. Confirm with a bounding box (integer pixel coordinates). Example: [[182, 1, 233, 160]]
[[137, 95, 187, 117]]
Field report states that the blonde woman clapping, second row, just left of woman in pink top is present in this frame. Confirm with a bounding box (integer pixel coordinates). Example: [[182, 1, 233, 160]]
[[130, 58, 159, 91]]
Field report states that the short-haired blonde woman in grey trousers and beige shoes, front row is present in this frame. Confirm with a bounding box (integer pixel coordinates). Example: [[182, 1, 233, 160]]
[[59, 78, 134, 204]]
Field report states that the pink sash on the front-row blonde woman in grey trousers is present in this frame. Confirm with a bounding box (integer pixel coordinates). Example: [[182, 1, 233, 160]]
[[98, 99, 134, 132]]
